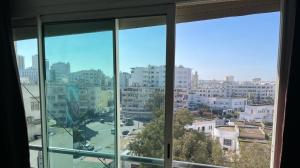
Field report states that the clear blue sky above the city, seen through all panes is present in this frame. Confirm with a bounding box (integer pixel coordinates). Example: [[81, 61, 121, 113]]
[[17, 12, 280, 80]]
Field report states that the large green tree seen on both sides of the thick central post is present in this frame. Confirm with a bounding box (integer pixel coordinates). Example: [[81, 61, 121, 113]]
[[128, 94, 224, 167]]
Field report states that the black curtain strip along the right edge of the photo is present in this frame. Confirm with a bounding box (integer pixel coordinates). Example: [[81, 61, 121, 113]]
[[281, 0, 300, 168]]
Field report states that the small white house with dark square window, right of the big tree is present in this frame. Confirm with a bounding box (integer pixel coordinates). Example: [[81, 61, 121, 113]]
[[212, 126, 239, 151]]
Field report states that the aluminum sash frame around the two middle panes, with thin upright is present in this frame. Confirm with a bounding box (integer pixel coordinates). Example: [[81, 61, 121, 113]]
[[37, 4, 176, 168]]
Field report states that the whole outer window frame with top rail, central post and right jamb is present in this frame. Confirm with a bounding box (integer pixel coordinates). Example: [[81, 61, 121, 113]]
[[12, 0, 295, 168]]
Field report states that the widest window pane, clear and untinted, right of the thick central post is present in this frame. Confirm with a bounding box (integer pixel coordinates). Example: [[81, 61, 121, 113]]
[[173, 12, 280, 168]]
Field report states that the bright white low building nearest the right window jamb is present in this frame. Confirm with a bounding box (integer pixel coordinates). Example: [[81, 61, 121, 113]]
[[239, 105, 274, 122]]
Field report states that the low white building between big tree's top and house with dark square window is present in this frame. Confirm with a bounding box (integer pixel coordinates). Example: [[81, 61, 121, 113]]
[[185, 120, 216, 135]]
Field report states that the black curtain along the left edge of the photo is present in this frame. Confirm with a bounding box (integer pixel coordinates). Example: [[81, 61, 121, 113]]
[[0, 0, 30, 168]]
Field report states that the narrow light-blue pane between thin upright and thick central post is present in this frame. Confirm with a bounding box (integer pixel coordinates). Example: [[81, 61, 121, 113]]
[[119, 16, 166, 168]]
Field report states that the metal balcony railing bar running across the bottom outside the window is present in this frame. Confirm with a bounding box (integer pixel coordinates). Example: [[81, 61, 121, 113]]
[[29, 145, 224, 168]]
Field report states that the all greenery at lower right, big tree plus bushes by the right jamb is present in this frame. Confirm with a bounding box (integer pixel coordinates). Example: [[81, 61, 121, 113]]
[[128, 92, 270, 168]]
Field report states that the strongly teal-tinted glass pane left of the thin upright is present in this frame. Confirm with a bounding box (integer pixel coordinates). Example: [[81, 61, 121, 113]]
[[44, 20, 116, 167]]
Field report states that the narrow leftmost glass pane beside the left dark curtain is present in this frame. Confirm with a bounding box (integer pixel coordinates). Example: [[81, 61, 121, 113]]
[[13, 27, 41, 168]]
